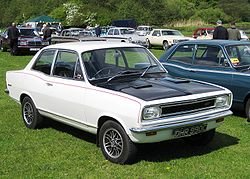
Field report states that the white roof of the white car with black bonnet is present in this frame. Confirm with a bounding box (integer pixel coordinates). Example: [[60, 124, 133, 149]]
[[43, 41, 141, 53]]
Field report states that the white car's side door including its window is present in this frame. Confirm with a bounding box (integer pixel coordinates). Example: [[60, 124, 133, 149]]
[[48, 50, 86, 122]]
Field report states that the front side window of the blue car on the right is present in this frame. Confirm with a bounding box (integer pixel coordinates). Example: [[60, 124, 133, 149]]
[[194, 45, 224, 66]]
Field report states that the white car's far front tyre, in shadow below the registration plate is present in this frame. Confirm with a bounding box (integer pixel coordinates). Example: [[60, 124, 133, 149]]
[[184, 129, 215, 146]]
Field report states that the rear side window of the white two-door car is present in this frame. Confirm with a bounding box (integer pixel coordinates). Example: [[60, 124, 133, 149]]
[[32, 50, 56, 75]]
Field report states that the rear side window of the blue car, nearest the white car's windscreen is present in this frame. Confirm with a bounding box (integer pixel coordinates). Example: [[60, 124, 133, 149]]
[[169, 45, 194, 64]]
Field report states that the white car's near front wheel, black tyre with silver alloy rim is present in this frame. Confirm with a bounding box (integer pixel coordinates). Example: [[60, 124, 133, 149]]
[[99, 120, 137, 164]]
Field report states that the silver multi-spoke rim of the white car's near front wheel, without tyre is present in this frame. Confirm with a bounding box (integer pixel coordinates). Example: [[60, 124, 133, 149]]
[[103, 128, 123, 158]]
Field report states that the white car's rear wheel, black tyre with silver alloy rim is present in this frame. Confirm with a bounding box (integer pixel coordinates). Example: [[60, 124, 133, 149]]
[[22, 97, 42, 129]]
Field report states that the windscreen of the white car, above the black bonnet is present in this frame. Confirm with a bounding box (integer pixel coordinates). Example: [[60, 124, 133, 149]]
[[82, 48, 166, 81]]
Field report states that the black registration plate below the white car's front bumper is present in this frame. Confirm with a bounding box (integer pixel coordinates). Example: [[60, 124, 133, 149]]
[[173, 124, 207, 138]]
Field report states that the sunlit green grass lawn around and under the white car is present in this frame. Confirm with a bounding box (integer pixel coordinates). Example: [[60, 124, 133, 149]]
[[0, 50, 250, 179]]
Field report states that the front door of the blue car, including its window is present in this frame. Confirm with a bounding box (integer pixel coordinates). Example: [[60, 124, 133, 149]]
[[189, 45, 234, 89]]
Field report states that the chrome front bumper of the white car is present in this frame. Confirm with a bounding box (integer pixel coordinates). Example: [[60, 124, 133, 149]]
[[129, 110, 233, 133]]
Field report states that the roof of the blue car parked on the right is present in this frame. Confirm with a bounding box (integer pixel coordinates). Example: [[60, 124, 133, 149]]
[[179, 39, 250, 46]]
